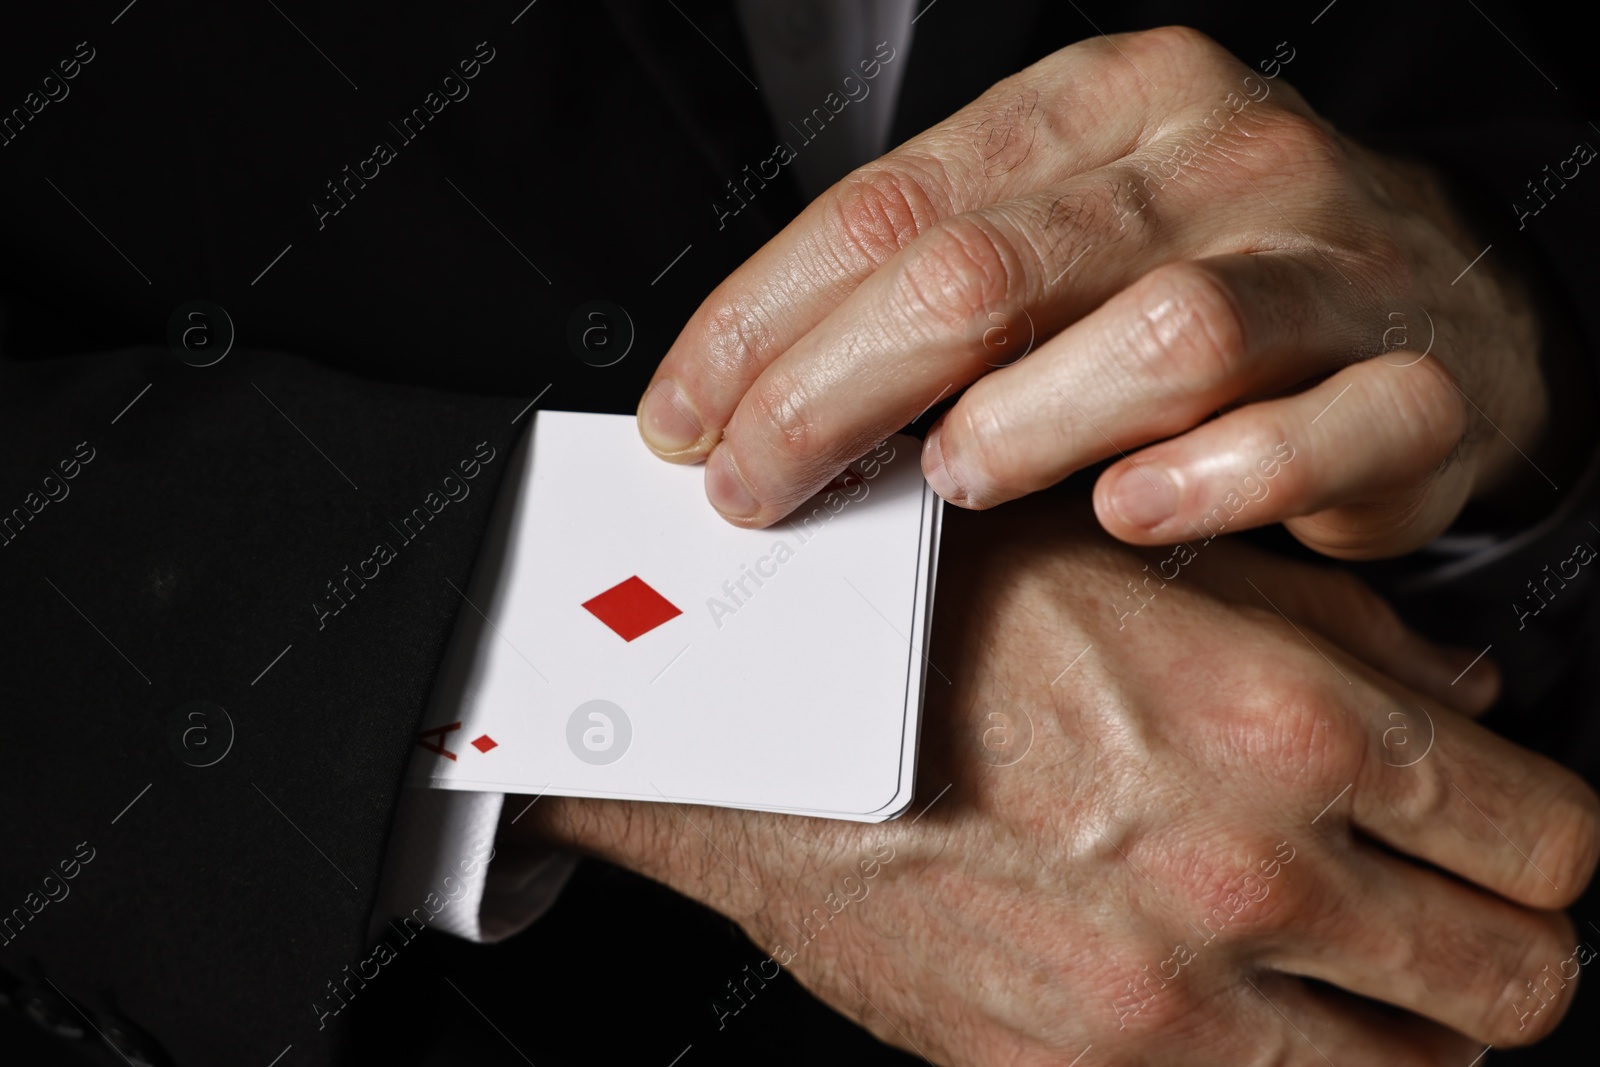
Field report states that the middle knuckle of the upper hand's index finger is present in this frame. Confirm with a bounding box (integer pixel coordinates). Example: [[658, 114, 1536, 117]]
[[827, 158, 947, 269]]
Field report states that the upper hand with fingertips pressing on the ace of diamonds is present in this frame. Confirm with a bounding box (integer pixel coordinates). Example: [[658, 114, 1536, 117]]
[[638, 29, 1549, 557]]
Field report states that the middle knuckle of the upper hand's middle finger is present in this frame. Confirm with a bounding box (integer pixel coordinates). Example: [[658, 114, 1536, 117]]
[[899, 216, 1022, 333]]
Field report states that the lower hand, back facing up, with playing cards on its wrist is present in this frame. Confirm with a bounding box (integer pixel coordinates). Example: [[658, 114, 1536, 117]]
[[502, 498, 1600, 1067]]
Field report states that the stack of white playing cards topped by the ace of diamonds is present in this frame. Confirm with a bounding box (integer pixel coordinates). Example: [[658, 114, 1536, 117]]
[[411, 411, 942, 822]]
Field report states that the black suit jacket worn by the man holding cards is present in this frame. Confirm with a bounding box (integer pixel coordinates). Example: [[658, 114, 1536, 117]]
[[0, 0, 1600, 1067]]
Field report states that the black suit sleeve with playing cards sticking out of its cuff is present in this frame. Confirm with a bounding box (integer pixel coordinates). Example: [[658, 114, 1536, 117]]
[[0, 349, 526, 1064]]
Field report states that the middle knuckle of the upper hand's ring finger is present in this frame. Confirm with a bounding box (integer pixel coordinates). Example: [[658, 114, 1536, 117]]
[[1133, 262, 1250, 394]]
